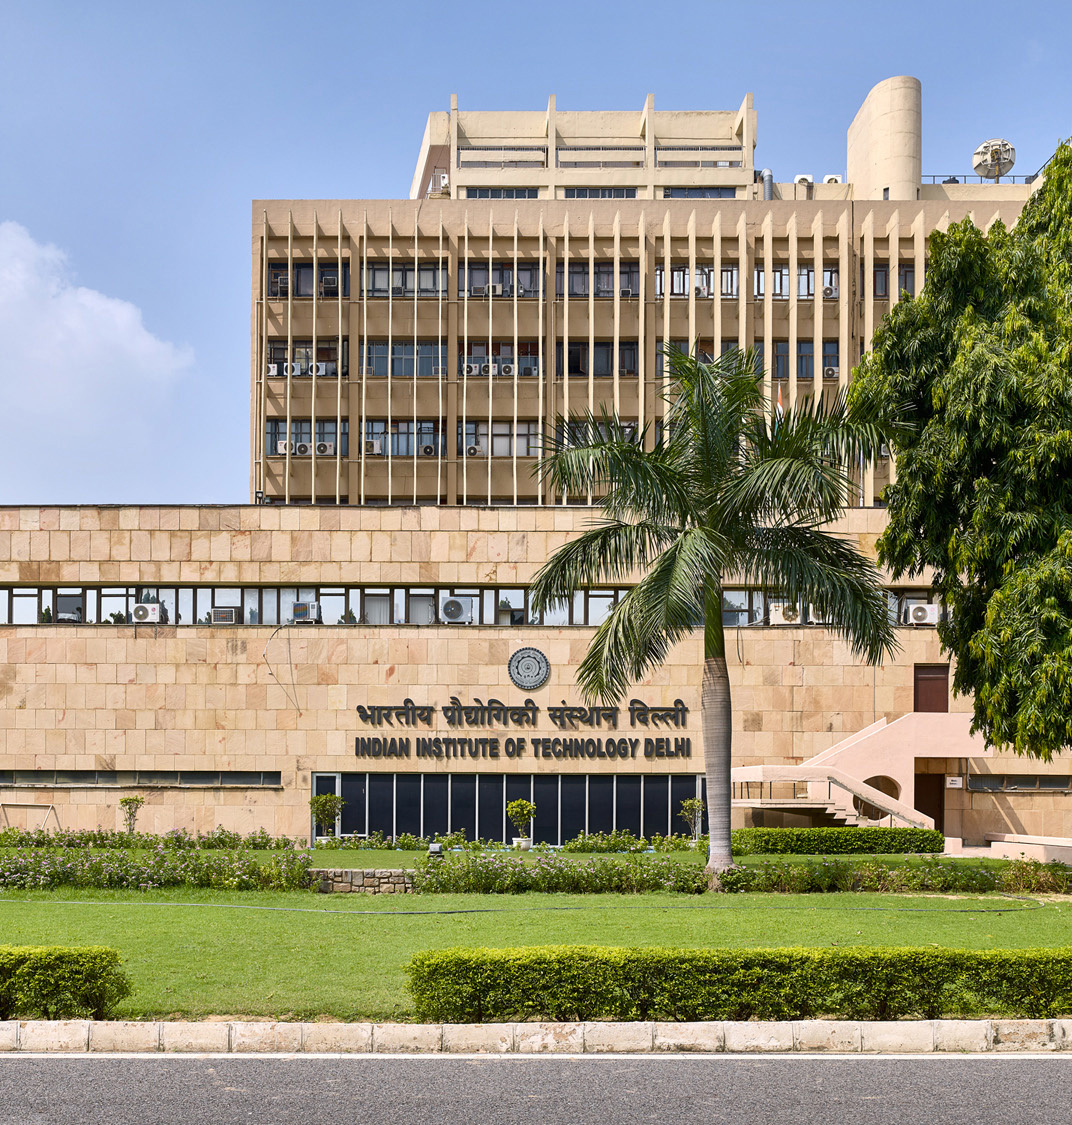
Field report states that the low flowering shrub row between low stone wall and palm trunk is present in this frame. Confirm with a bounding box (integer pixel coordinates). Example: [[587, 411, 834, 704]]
[[413, 852, 708, 894]]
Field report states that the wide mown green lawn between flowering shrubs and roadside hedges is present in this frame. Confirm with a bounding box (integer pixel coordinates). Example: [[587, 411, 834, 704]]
[[0, 889, 1072, 1019]]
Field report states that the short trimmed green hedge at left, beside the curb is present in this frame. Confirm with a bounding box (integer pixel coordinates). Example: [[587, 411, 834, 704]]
[[0, 945, 132, 1019]]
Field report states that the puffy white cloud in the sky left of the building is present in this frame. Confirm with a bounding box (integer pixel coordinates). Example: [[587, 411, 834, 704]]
[[0, 222, 193, 503]]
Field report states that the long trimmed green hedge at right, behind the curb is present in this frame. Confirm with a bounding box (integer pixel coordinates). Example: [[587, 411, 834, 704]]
[[406, 946, 1072, 1024]]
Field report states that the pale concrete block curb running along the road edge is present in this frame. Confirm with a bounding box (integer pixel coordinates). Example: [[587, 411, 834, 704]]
[[0, 1019, 1072, 1054]]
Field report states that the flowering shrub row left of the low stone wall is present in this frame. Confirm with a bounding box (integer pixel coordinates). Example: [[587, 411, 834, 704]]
[[0, 843, 310, 891]]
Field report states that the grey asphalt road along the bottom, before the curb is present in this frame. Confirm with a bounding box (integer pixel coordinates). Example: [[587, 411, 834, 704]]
[[0, 1055, 1072, 1125]]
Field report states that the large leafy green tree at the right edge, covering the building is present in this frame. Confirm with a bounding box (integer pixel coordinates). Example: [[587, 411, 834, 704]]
[[850, 138, 1072, 759]]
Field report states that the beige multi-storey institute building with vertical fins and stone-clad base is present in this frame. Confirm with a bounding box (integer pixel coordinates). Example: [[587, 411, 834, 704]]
[[0, 79, 1057, 843]]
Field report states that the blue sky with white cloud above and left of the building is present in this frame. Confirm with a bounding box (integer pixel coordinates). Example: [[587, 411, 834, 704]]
[[0, 0, 1072, 503]]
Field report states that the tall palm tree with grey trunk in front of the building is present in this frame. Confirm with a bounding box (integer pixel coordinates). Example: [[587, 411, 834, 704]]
[[532, 350, 895, 873]]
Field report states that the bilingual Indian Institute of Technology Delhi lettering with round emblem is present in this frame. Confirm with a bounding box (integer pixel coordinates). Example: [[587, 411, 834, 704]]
[[354, 648, 692, 765]]
